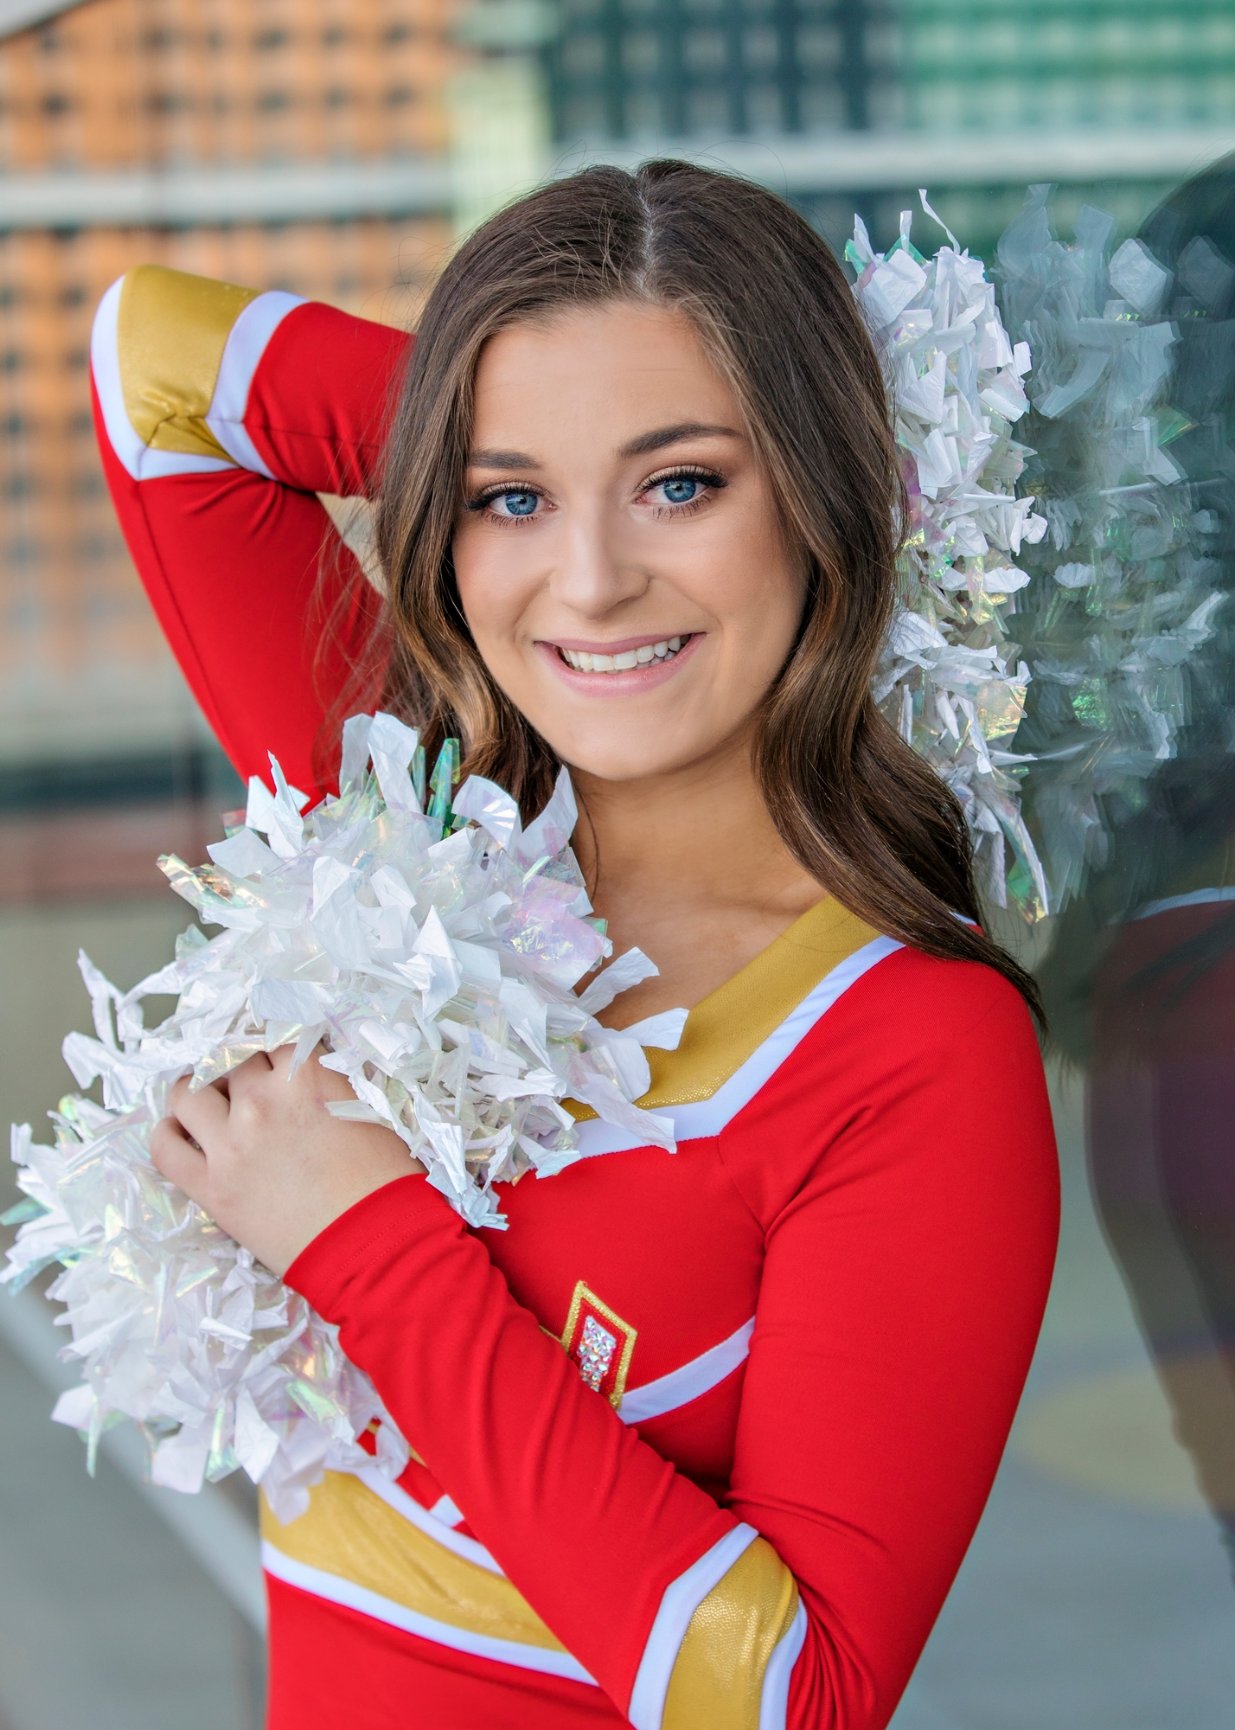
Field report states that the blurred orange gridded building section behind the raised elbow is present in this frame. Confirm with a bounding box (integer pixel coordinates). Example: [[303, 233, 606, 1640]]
[[0, 0, 455, 771]]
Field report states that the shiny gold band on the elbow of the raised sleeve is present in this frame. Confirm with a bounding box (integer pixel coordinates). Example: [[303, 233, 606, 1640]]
[[116, 265, 261, 462]]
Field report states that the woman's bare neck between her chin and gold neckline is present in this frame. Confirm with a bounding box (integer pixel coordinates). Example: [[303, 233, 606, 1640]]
[[571, 742, 822, 913]]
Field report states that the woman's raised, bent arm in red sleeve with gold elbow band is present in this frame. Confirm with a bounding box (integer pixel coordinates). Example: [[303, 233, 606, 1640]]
[[90, 265, 415, 801]]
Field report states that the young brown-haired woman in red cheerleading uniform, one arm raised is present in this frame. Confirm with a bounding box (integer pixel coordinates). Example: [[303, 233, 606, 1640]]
[[93, 161, 1059, 1730]]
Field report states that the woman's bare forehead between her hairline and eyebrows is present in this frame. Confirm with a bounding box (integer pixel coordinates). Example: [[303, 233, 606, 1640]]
[[474, 301, 737, 431]]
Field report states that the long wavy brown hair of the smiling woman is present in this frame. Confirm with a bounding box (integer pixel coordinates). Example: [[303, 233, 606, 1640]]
[[307, 157, 1043, 1022]]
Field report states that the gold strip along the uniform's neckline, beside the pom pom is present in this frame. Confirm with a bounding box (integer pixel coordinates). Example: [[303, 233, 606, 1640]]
[[562, 894, 880, 1123]]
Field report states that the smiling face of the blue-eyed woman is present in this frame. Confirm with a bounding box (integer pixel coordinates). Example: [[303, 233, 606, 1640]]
[[451, 299, 806, 803]]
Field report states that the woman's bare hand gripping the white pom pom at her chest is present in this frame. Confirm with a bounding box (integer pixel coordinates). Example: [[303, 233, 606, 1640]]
[[149, 1041, 424, 1277]]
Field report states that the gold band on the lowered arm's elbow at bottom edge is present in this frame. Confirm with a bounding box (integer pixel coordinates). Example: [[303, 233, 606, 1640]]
[[661, 1538, 797, 1730]]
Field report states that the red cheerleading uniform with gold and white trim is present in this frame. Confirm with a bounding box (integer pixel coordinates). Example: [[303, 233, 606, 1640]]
[[92, 265, 1059, 1730]]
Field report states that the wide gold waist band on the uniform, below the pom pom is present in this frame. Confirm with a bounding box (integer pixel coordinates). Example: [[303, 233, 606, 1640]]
[[259, 1472, 566, 1652]]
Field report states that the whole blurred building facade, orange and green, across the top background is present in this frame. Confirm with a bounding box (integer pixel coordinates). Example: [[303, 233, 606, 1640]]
[[0, 0, 1235, 781]]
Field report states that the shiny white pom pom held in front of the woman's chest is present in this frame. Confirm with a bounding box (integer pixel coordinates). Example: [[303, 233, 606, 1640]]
[[0, 711, 683, 1519]]
